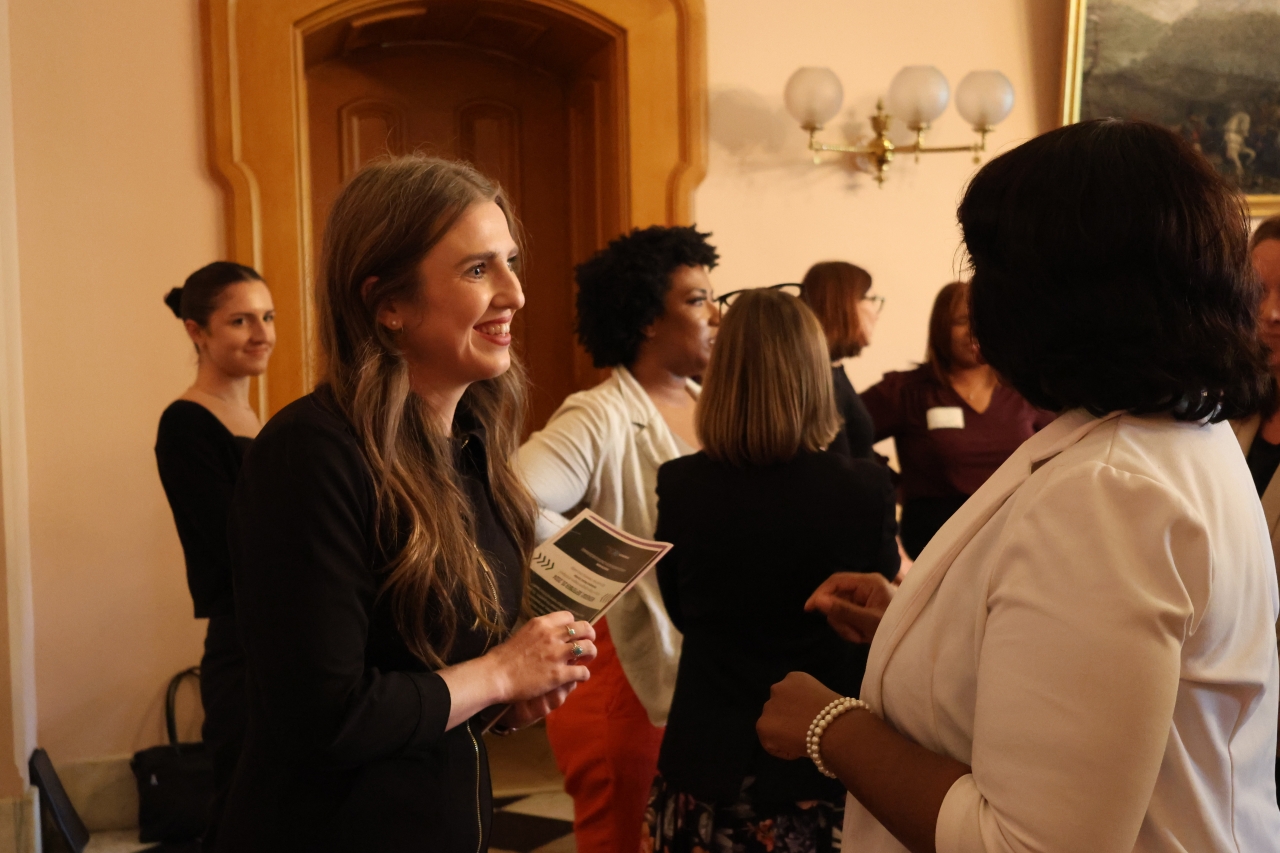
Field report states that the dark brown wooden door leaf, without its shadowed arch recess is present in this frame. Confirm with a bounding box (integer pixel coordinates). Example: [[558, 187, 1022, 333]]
[[307, 44, 573, 427]]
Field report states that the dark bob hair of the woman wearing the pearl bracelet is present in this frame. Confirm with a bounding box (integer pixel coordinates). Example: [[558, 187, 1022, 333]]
[[959, 119, 1270, 421]]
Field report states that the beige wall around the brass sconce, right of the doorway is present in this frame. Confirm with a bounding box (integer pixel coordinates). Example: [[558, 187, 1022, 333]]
[[696, 0, 1065, 399]]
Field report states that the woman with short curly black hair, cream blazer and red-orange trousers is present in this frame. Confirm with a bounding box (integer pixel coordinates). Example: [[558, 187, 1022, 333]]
[[520, 225, 719, 853]]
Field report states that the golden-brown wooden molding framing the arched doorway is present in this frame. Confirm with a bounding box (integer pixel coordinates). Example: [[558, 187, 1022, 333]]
[[202, 0, 707, 415]]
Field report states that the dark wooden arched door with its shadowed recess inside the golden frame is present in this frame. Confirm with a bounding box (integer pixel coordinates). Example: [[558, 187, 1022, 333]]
[[305, 0, 622, 428]]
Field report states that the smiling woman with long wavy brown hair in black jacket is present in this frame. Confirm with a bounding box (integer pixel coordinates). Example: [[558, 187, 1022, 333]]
[[218, 158, 595, 853]]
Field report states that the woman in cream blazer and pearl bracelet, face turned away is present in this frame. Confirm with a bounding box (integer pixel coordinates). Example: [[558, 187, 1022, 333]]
[[758, 119, 1280, 853]]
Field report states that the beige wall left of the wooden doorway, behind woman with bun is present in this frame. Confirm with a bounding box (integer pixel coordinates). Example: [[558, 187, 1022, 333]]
[[10, 0, 221, 762]]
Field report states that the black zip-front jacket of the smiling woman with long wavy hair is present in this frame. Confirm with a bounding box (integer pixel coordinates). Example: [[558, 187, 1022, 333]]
[[218, 387, 522, 853]]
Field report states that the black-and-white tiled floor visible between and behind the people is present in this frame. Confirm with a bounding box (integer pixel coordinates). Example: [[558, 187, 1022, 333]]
[[84, 726, 577, 853]]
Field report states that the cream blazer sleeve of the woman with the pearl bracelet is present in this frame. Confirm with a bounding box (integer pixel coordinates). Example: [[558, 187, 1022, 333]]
[[934, 462, 1212, 853]]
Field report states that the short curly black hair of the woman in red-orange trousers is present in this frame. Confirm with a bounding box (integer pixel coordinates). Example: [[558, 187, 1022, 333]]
[[576, 225, 719, 368]]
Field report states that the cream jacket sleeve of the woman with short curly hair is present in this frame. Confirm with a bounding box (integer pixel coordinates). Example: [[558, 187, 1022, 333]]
[[518, 397, 608, 542]]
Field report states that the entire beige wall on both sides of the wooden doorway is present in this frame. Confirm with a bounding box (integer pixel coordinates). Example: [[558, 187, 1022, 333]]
[[0, 0, 1061, 762]]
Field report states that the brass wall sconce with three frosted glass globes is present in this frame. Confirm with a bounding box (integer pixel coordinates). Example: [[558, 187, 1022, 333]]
[[785, 65, 1014, 186]]
